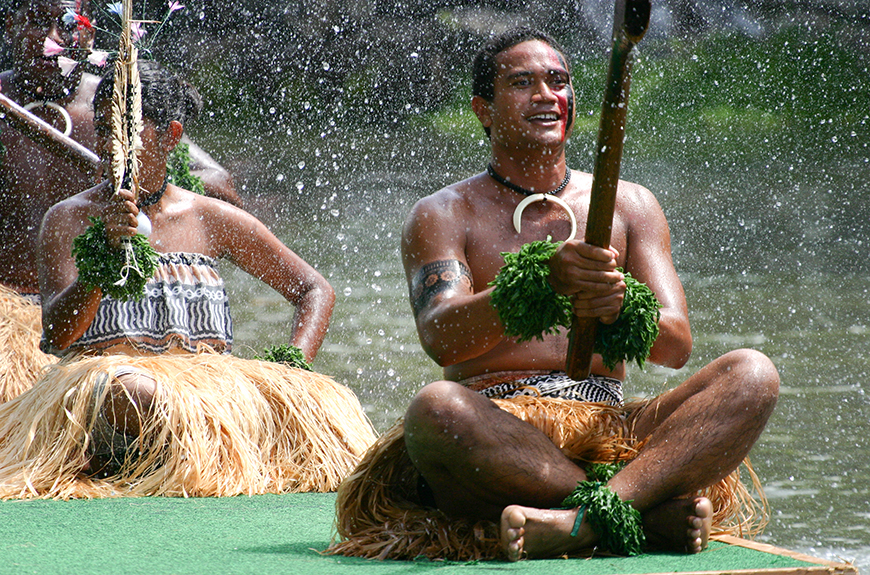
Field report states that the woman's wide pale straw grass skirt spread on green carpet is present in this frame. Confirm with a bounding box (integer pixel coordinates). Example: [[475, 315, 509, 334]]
[[0, 352, 375, 499]]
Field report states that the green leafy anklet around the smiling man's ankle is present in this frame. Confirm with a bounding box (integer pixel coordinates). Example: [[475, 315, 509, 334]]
[[562, 481, 646, 556]]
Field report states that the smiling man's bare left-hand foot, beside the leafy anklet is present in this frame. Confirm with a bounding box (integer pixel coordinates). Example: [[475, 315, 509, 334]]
[[499, 505, 595, 561]]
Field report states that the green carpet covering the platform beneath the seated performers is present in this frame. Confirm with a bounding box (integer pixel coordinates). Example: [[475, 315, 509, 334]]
[[0, 493, 836, 575]]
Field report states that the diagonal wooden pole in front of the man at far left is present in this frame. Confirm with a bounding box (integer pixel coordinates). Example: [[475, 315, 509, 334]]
[[0, 94, 100, 176]]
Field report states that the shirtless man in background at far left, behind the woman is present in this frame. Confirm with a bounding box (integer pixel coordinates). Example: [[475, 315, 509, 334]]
[[0, 0, 242, 294]]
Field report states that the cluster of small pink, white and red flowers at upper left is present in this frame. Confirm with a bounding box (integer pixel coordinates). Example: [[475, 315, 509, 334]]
[[42, 0, 185, 77]]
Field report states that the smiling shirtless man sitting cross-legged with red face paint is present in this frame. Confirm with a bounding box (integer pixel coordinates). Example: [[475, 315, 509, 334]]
[[402, 30, 779, 560]]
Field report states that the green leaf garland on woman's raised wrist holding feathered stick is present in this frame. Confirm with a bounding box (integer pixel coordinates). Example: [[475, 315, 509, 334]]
[[72, 217, 158, 301]]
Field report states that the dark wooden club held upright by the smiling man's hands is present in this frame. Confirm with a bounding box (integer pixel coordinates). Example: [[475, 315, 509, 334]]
[[566, 0, 651, 380]]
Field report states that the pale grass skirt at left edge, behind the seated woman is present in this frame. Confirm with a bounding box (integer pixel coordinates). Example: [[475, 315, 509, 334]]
[[0, 286, 57, 403]]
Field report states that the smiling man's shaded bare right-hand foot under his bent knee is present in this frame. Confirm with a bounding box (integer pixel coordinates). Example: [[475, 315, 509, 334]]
[[643, 497, 713, 554]]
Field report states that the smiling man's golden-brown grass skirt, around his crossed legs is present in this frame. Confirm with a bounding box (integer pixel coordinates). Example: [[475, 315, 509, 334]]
[[327, 397, 767, 561]]
